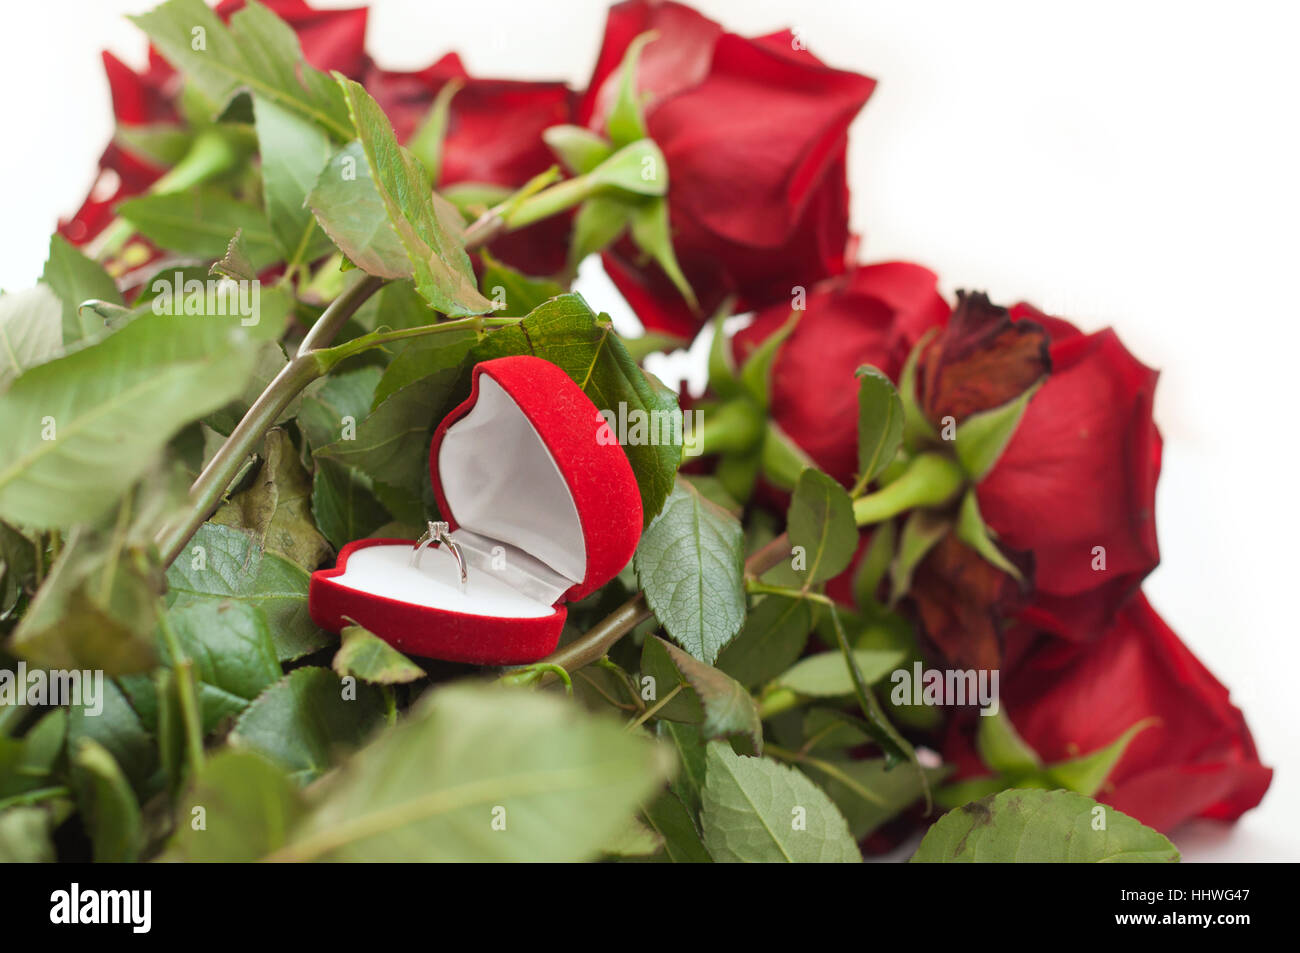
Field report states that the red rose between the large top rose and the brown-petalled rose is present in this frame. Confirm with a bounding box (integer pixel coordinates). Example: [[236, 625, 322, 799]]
[[733, 261, 949, 486]]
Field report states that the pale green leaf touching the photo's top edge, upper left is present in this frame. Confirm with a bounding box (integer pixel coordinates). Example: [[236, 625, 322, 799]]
[[130, 0, 352, 139]]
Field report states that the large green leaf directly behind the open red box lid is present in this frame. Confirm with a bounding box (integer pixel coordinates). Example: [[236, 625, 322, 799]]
[[473, 294, 681, 525]]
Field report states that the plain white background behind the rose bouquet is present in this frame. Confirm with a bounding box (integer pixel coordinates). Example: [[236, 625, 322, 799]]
[[0, 0, 1300, 861]]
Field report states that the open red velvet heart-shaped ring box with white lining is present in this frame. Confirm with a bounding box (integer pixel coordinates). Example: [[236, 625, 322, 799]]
[[308, 355, 641, 666]]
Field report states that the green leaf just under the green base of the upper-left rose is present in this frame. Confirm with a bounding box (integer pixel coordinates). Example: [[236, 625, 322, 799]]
[[117, 186, 281, 265]]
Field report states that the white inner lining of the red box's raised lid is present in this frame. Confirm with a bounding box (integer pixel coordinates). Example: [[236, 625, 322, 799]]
[[438, 373, 586, 582]]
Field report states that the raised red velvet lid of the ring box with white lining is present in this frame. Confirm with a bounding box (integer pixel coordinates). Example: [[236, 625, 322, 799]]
[[429, 355, 642, 599]]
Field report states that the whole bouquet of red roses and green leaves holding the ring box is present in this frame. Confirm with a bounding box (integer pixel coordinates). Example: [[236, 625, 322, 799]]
[[0, 0, 1271, 862]]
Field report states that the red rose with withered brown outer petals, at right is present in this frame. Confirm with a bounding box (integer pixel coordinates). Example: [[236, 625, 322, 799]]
[[910, 294, 1161, 668]]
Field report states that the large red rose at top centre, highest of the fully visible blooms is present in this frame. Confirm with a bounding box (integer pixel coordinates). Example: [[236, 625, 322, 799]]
[[579, 0, 875, 338]]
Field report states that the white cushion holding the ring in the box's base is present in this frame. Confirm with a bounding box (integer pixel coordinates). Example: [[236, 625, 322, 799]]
[[333, 546, 555, 619]]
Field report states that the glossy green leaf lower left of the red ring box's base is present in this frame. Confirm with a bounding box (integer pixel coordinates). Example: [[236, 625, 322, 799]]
[[168, 601, 283, 733]]
